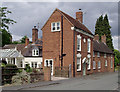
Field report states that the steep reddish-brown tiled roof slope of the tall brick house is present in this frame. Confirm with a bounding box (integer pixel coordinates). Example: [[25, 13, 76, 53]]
[[56, 9, 93, 35]]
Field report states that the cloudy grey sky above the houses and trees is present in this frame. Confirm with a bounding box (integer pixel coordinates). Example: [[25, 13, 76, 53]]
[[2, 1, 118, 49]]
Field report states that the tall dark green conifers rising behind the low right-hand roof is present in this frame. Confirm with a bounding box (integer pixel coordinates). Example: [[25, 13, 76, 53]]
[[95, 14, 114, 50]]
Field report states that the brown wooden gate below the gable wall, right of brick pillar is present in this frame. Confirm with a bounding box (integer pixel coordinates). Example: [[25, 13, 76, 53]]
[[55, 67, 69, 77]]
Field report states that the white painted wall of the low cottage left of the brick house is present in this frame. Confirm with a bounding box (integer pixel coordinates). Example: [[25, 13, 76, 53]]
[[24, 57, 42, 68]]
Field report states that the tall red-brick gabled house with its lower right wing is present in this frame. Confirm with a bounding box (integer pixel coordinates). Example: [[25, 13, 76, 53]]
[[41, 9, 114, 77]]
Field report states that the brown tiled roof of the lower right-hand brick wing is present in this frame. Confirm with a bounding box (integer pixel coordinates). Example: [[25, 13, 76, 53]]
[[93, 40, 113, 54]]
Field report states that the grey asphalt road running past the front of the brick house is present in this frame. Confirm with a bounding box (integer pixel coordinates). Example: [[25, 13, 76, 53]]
[[22, 72, 118, 90]]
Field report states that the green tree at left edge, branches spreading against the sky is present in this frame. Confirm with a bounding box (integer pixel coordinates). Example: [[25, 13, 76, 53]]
[[0, 7, 16, 46]]
